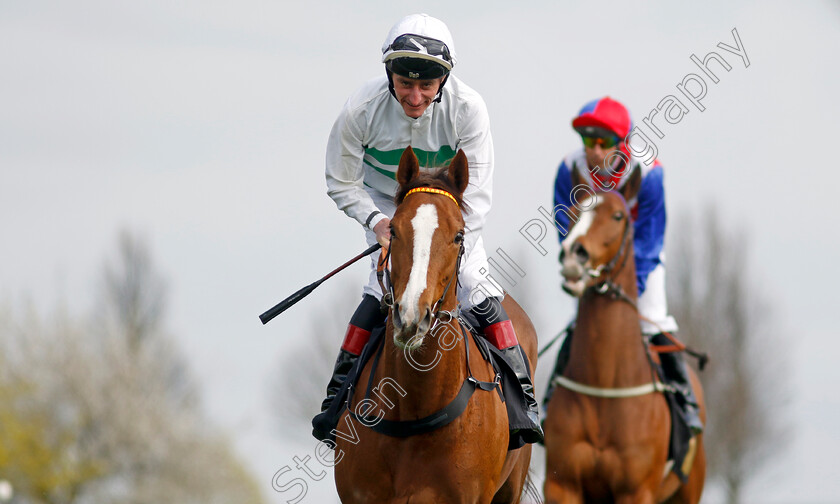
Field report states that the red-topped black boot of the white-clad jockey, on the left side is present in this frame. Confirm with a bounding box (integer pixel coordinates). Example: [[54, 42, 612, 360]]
[[321, 295, 385, 412]]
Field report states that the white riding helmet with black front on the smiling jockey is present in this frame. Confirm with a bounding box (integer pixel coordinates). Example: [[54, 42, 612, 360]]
[[382, 14, 456, 79]]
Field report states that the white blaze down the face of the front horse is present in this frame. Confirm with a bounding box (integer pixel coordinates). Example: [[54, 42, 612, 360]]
[[399, 203, 438, 324]]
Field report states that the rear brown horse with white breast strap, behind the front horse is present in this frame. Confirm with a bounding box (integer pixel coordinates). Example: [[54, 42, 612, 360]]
[[544, 170, 705, 504]]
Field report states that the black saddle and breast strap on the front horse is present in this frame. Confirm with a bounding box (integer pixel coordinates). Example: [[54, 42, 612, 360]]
[[312, 313, 530, 450]]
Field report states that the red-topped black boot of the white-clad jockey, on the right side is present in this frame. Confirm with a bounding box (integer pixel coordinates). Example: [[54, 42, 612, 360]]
[[472, 298, 543, 443]]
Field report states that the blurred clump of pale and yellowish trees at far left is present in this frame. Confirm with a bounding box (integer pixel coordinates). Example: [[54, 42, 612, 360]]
[[0, 234, 264, 504]]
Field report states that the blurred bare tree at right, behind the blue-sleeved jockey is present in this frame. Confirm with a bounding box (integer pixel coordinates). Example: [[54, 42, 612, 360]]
[[668, 207, 790, 504]]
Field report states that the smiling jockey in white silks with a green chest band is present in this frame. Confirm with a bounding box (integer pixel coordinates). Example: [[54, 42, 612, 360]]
[[313, 14, 542, 442]]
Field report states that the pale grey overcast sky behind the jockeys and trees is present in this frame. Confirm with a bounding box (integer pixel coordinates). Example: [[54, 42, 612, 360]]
[[0, 0, 840, 503]]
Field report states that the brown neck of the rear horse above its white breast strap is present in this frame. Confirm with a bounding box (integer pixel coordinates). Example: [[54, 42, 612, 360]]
[[566, 246, 650, 387]]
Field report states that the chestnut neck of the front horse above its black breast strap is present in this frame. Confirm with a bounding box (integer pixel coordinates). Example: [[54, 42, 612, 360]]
[[380, 320, 466, 420]]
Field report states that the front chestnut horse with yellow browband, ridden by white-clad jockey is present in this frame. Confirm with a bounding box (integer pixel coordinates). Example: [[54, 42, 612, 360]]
[[335, 147, 537, 504]]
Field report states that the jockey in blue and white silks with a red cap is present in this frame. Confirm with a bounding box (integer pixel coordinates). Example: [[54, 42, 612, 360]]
[[543, 96, 703, 432]]
